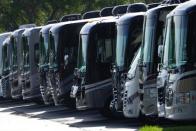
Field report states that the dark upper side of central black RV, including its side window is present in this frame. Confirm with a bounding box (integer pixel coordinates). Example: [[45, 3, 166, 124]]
[[86, 22, 116, 84]]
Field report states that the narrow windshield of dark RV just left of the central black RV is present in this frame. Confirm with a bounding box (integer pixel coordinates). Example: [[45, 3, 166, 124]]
[[48, 33, 58, 66]]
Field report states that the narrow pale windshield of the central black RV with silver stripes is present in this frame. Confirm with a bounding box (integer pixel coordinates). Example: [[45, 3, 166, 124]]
[[77, 34, 88, 68]]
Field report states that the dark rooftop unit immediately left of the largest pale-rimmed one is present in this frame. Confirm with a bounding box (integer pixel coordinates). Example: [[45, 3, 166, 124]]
[[112, 5, 128, 16]]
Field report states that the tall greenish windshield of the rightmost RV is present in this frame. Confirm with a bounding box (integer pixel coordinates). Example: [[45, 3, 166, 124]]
[[163, 16, 189, 68]]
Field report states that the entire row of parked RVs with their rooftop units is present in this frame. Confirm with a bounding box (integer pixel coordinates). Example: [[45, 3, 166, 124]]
[[0, 0, 196, 126]]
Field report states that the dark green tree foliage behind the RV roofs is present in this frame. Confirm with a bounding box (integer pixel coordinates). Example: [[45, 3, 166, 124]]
[[0, 0, 162, 32]]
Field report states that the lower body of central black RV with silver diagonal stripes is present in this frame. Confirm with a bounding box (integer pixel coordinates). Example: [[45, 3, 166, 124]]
[[76, 79, 112, 110]]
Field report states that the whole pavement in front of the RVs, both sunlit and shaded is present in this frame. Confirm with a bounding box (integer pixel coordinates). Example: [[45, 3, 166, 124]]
[[0, 99, 195, 131]]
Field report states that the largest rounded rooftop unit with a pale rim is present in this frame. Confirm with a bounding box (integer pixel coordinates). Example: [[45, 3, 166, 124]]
[[127, 3, 147, 13]]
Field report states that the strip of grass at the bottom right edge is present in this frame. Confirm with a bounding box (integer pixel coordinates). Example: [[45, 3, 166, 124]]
[[139, 125, 196, 131]]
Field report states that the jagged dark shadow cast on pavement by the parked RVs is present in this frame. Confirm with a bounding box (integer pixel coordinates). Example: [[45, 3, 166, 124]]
[[0, 100, 195, 129]]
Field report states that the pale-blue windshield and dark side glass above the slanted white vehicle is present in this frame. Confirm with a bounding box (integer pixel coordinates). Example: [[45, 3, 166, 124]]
[[116, 19, 143, 69]]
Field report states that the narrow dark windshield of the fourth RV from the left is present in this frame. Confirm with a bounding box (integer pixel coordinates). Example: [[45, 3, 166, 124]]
[[22, 36, 29, 69]]
